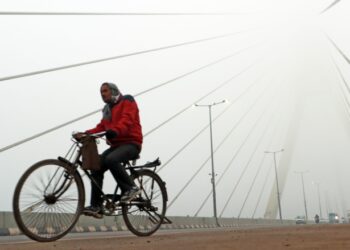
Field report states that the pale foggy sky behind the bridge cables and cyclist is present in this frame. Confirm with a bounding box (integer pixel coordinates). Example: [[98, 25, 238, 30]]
[[0, 0, 350, 218]]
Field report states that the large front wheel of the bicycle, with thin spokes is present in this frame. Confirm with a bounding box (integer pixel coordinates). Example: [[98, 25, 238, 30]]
[[13, 160, 85, 242]]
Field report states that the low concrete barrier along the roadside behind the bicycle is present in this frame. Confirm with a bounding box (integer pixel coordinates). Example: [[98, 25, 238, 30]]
[[0, 212, 295, 236]]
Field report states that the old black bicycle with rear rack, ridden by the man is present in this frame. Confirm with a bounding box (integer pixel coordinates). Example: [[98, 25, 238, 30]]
[[13, 133, 171, 242]]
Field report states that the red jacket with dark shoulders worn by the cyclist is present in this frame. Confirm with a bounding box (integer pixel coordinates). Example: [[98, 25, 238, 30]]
[[86, 95, 143, 149]]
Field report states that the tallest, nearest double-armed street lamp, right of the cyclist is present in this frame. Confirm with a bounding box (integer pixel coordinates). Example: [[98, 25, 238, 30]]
[[195, 100, 227, 226]]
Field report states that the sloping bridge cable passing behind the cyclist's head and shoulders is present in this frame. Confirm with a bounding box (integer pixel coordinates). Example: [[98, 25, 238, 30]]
[[0, 43, 262, 153]]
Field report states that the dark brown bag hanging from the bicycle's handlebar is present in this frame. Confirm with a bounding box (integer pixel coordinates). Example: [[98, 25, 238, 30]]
[[81, 136, 101, 171]]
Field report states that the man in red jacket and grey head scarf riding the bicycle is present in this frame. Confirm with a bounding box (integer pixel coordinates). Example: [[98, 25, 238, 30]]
[[75, 82, 143, 218]]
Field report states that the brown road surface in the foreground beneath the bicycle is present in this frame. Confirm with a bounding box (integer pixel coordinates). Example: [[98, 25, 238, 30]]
[[0, 224, 350, 250]]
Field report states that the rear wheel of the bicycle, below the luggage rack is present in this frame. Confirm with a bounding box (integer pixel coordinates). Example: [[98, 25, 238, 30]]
[[122, 170, 167, 236]]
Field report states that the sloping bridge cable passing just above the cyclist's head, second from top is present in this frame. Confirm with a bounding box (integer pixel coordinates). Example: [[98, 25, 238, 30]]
[[0, 29, 260, 82]]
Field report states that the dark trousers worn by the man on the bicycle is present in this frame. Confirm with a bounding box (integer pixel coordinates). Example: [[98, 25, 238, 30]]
[[90, 144, 140, 206]]
